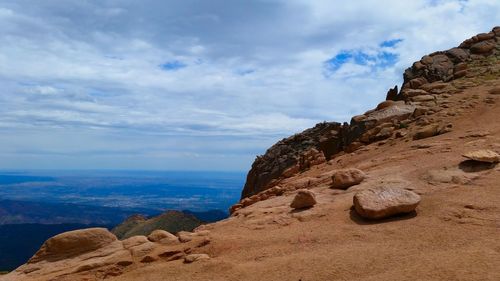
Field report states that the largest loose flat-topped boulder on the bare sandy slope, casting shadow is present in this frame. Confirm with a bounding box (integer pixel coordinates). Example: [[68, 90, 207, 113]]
[[353, 187, 420, 219]]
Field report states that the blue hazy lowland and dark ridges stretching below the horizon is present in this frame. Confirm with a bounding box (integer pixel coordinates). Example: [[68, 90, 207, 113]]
[[0, 171, 245, 270]]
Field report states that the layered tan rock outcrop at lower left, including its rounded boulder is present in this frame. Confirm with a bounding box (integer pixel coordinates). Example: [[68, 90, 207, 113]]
[[9, 228, 210, 280]]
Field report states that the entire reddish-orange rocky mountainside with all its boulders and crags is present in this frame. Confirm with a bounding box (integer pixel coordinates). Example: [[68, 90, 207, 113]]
[[0, 27, 500, 281]]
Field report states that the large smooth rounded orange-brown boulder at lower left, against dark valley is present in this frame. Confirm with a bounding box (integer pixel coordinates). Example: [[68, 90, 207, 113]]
[[29, 225, 117, 263]]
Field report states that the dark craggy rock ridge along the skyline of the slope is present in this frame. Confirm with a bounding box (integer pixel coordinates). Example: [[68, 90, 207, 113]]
[[239, 27, 500, 206]]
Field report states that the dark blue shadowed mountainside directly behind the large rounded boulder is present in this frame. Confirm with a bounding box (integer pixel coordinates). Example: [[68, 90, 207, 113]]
[[0, 222, 109, 271]]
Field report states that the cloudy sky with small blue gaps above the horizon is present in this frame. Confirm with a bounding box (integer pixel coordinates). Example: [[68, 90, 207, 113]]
[[0, 0, 500, 171]]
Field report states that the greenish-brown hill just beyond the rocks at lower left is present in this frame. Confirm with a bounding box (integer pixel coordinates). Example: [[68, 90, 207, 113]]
[[111, 211, 202, 239]]
